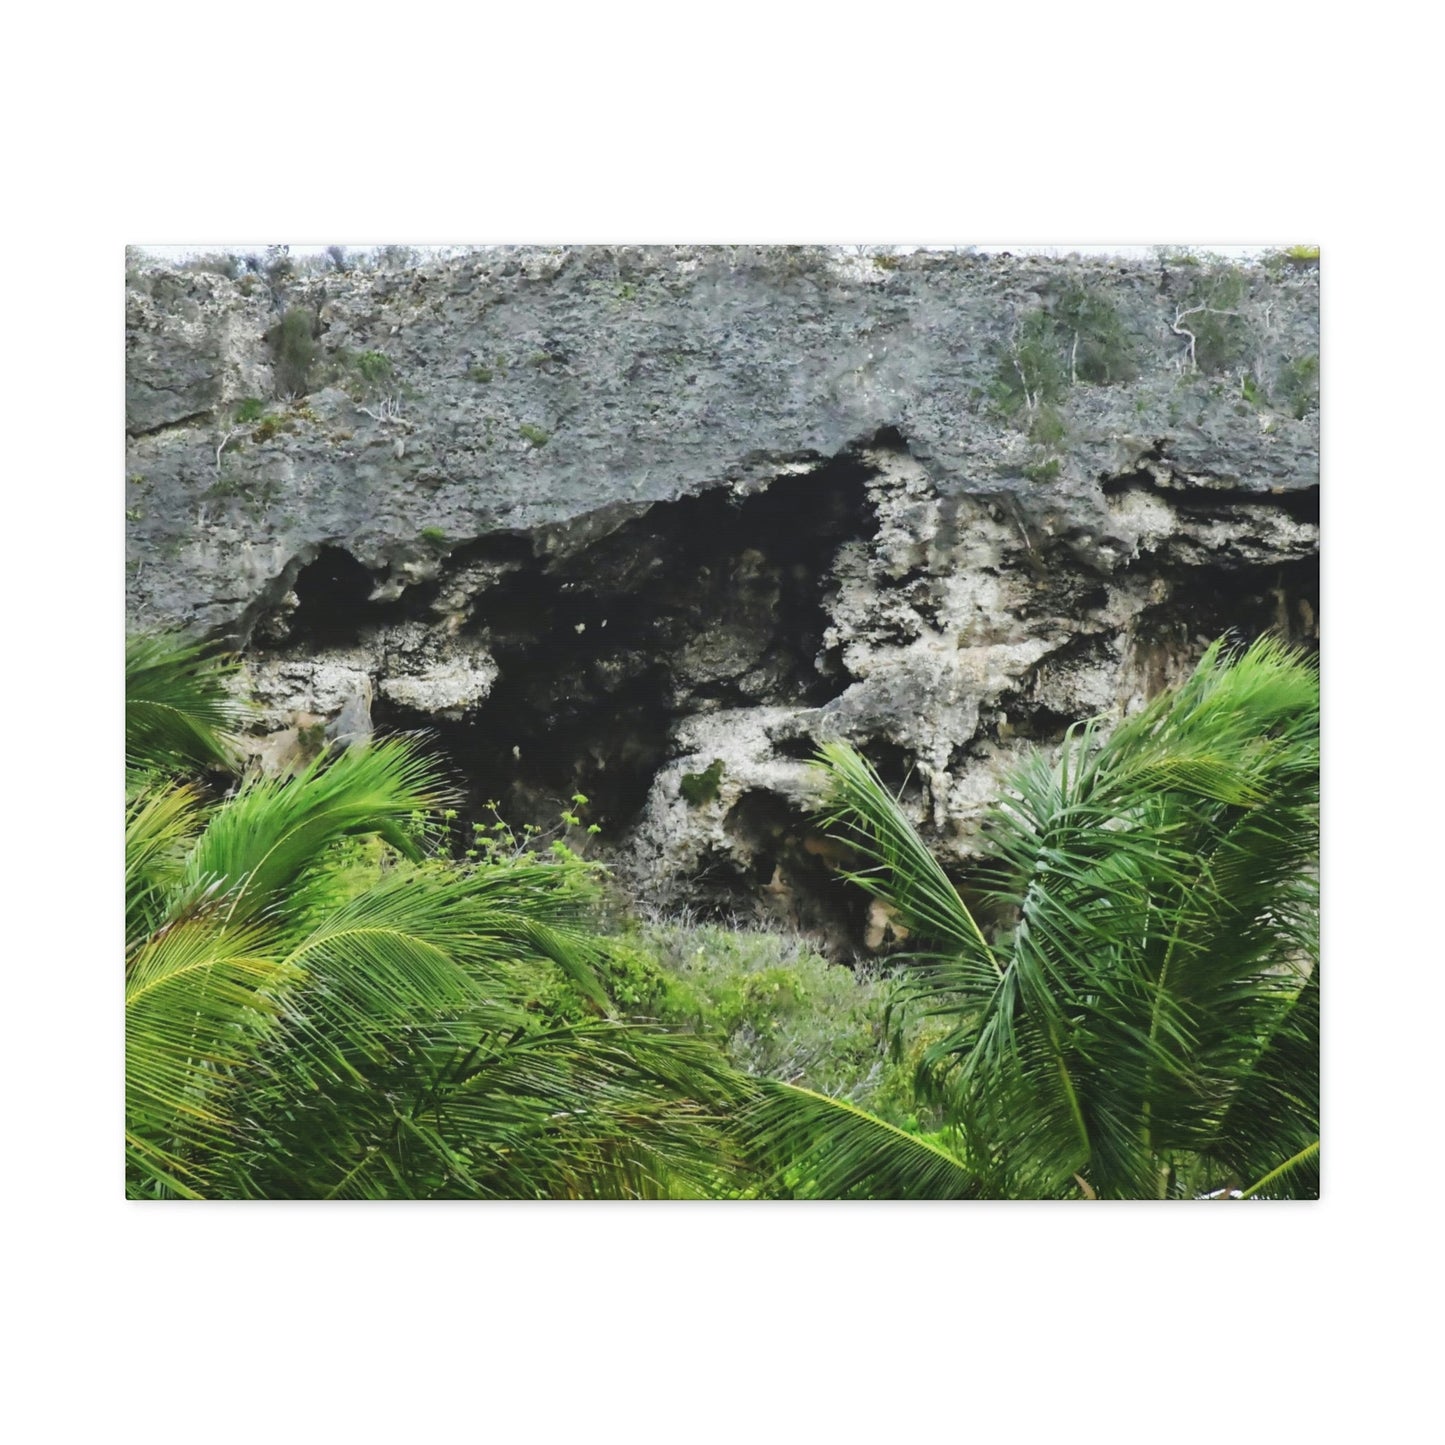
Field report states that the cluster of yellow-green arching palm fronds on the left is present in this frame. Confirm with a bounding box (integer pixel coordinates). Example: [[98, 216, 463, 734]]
[[126, 639, 744, 1198]]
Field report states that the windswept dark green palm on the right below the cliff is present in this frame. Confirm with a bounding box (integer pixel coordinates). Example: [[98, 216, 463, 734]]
[[751, 639, 1319, 1198]]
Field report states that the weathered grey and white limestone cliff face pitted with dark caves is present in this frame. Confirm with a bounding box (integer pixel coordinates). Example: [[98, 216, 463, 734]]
[[126, 247, 1319, 942]]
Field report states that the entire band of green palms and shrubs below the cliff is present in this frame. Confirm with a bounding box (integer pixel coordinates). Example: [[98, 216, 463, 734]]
[[126, 637, 1319, 1198]]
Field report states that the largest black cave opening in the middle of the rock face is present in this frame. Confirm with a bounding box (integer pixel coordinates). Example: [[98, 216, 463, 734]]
[[367, 457, 876, 840]]
